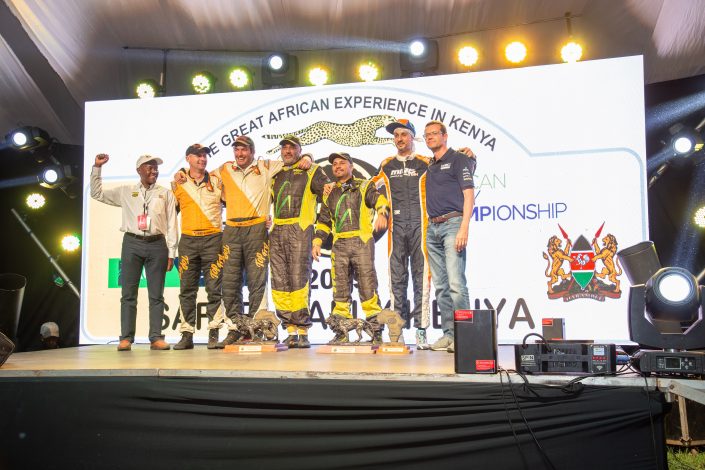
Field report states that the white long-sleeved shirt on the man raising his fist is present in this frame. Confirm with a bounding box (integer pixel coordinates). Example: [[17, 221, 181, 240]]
[[91, 166, 178, 258]]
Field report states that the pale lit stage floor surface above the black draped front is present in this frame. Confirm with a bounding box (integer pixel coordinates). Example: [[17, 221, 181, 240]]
[[0, 344, 656, 387]]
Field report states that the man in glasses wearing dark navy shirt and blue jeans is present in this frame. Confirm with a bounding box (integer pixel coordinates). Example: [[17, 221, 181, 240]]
[[423, 121, 476, 352]]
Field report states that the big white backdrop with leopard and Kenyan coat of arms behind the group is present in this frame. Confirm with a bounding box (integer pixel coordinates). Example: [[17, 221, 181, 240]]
[[81, 57, 648, 344]]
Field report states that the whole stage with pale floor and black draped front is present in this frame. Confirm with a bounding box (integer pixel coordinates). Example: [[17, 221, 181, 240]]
[[0, 344, 667, 470]]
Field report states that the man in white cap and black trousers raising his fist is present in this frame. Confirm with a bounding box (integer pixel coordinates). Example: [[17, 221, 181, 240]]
[[91, 153, 178, 351]]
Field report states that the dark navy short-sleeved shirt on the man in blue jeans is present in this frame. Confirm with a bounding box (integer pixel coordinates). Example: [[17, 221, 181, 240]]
[[426, 148, 476, 217]]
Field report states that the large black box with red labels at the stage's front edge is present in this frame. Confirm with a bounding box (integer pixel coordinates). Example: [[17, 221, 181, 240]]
[[454, 310, 497, 374]]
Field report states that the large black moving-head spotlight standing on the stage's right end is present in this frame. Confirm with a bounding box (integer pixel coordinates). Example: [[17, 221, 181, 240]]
[[617, 241, 705, 375]]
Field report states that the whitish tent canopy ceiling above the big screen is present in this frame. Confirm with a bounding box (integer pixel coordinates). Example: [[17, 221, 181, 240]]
[[0, 0, 705, 144]]
